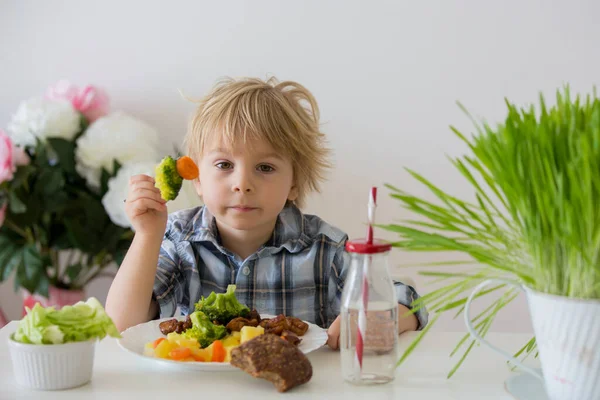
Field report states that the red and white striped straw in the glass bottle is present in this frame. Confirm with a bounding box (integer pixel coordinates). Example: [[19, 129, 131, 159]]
[[356, 187, 377, 371]]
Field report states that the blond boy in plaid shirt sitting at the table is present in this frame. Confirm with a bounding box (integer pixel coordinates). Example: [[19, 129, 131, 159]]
[[106, 79, 427, 348]]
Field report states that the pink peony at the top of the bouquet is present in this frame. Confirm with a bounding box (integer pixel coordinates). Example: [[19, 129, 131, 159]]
[[46, 80, 109, 122]]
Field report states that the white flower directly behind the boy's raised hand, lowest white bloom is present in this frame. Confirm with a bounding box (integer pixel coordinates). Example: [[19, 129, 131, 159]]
[[102, 162, 200, 228]]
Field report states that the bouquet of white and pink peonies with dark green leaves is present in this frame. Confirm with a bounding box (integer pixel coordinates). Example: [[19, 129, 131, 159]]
[[0, 81, 193, 307]]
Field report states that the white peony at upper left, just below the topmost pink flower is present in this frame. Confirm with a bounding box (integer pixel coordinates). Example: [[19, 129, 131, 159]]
[[8, 97, 81, 146]]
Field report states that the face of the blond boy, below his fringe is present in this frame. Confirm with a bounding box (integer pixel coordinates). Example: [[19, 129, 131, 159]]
[[195, 137, 298, 230]]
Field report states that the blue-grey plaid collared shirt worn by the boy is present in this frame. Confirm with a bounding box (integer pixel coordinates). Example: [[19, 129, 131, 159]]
[[153, 205, 427, 329]]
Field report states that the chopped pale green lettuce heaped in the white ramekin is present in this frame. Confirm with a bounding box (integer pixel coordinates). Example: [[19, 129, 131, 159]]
[[12, 297, 121, 344]]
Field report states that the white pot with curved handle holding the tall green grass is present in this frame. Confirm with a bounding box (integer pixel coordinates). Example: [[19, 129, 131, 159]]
[[464, 279, 600, 400]]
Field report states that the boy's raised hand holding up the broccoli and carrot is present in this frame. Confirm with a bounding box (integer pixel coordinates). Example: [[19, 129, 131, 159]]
[[125, 175, 168, 236]]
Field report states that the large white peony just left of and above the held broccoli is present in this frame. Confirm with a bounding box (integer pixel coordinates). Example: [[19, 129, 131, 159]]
[[75, 112, 160, 188]]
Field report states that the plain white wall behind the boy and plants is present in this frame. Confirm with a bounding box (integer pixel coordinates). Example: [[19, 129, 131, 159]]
[[0, 0, 600, 331]]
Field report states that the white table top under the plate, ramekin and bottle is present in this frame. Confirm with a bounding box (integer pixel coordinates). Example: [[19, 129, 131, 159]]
[[0, 322, 536, 400]]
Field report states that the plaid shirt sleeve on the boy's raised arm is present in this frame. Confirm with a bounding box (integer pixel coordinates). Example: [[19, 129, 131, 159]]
[[152, 231, 183, 318]]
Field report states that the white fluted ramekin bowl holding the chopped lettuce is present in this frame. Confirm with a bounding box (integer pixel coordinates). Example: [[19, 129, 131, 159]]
[[8, 337, 96, 390]]
